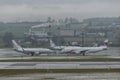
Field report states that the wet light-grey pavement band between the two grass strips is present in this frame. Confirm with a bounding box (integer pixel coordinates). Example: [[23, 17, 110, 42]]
[[0, 62, 120, 69]]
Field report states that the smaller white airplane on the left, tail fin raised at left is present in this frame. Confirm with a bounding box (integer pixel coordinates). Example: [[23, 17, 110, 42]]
[[12, 40, 54, 56]]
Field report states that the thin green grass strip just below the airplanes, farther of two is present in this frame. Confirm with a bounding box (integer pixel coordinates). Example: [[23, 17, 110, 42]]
[[0, 58, 120, 62]]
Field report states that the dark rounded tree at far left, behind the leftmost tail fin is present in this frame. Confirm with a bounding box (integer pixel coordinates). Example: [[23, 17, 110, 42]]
[[3, 32, 14, 47]]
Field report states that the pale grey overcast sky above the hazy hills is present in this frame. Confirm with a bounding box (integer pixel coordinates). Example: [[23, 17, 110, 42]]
[[0, 0, 120, 22]]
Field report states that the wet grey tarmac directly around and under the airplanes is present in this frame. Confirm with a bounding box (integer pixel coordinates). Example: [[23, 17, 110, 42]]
[[0, 47, 120, 58]]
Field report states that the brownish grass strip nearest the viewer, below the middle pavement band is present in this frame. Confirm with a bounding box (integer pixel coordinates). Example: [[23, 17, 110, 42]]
[[0, 68, 120, 76]]
